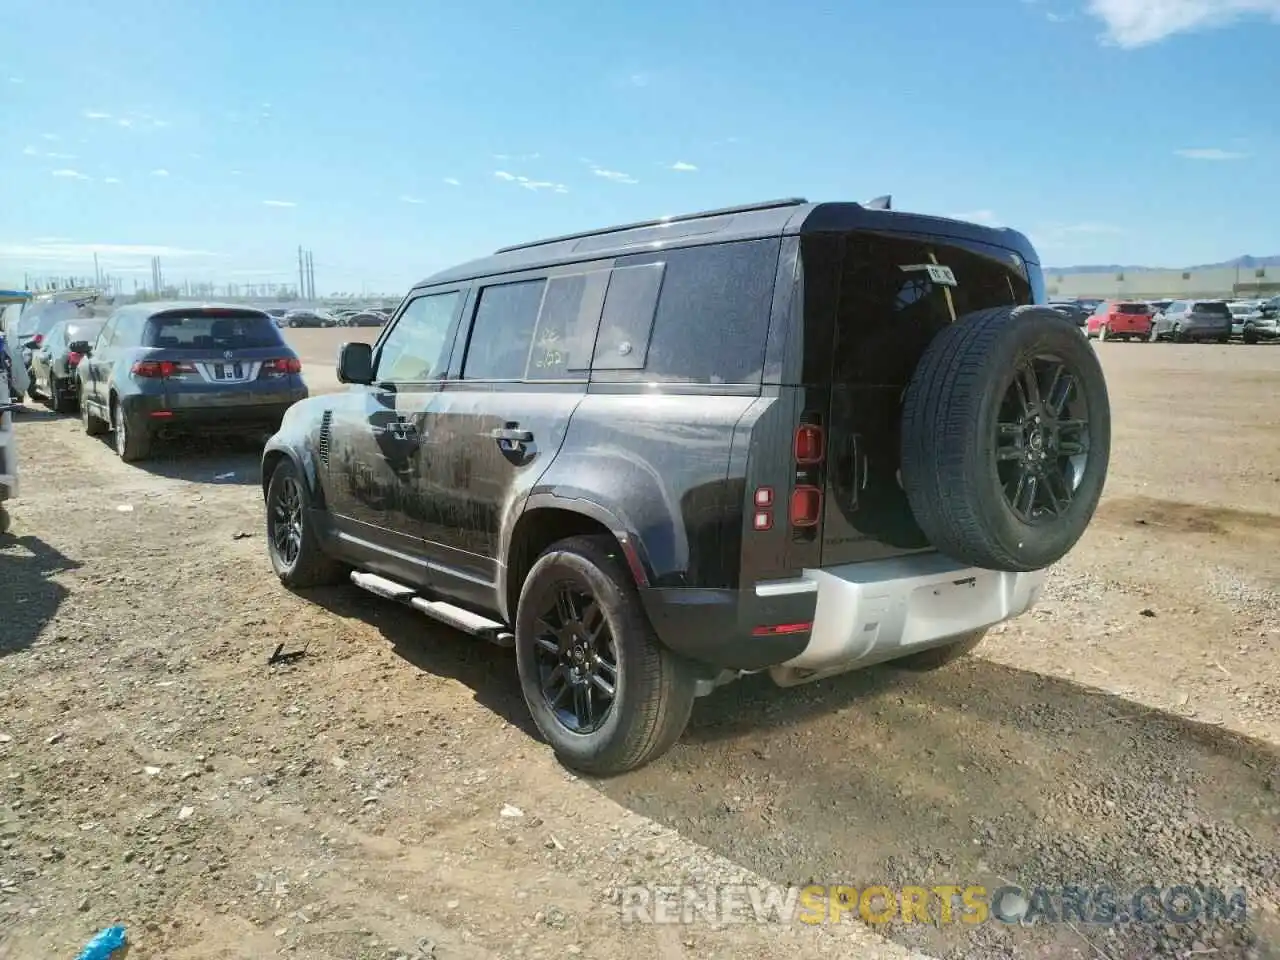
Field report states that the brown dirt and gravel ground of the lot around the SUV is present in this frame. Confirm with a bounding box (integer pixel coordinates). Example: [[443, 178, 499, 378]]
[[0, 330, 1280, 960]]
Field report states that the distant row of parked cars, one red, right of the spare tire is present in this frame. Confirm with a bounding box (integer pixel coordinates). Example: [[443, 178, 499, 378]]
[[1051, 297, 1280, 343]]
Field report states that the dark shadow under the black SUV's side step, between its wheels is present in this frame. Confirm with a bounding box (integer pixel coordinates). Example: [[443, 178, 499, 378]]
[[298, 586, 538, 739]]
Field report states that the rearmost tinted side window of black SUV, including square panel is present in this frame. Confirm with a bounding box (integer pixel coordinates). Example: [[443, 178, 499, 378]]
[[591, 239, 778, 383]]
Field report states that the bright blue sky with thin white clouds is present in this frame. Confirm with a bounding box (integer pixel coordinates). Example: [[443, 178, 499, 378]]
[[0, 0, 1280, 293]]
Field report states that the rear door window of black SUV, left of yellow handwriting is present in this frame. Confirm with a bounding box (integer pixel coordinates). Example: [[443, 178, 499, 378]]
[[462, 279, 547, 380]]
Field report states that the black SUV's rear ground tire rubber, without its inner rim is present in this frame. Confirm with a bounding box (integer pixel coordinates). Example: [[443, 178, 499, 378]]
[[516, 535, 695, 776]]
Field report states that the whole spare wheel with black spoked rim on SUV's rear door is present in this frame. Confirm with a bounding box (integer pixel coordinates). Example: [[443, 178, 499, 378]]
[[902, 306, 1111, 571]]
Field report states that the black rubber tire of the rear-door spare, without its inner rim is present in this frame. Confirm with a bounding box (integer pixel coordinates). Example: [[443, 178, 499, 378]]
[[901, 306, 1111, 572]]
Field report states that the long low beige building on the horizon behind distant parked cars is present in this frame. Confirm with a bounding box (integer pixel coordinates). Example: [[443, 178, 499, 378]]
[[1044, 266, 1280, 300]]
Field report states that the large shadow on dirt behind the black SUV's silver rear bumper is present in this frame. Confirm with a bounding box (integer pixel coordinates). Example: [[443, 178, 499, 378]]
[[594, 657, 1280, 960]]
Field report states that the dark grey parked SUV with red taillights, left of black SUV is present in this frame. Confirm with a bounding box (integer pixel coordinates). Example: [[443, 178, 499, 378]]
[[72, 303, 307, 461]]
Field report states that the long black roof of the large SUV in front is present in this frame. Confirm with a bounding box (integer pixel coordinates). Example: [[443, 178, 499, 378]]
[[416, 198, 1039, 287]]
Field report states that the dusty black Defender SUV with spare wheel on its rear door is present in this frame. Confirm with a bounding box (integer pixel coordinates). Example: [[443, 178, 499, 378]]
[[262, 200, 1110, 774]]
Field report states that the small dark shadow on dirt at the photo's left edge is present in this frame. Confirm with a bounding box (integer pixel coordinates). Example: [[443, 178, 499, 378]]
[[0, 534, 81, 657]]
